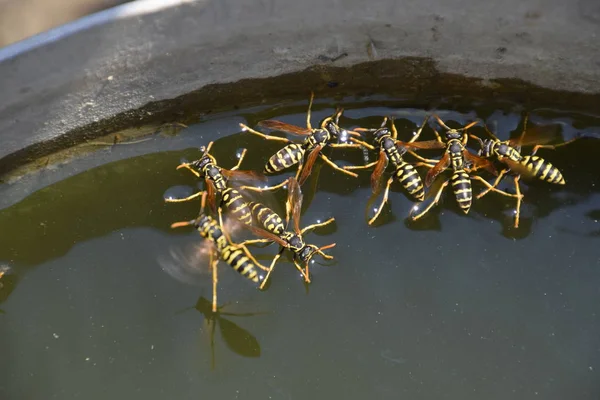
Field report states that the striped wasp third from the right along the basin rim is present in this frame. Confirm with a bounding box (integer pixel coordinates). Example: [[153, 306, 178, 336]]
[[344, 117, 428, 225]]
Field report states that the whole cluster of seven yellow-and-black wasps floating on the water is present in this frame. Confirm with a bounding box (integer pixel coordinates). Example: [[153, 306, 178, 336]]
[[166, 95, 570, 312]]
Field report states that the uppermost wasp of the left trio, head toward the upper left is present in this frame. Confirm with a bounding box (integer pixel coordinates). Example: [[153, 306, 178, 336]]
[[165, 142, 264, 224]]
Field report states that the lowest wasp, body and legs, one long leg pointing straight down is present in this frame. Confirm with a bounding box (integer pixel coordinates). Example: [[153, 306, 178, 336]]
[[165, 192, 268, 312]]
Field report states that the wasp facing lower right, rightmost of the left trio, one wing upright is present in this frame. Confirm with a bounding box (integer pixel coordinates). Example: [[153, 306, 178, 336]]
[[243, 177, 335, 289]]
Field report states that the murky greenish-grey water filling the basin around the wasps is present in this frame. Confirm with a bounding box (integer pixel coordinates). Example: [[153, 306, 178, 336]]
[[0, 98, 600, 400]]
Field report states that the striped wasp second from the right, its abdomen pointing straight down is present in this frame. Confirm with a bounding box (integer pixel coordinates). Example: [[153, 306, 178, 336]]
[[401, 115, 508, 220]]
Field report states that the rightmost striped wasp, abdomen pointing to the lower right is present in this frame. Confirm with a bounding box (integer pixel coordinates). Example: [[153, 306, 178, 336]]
[[470, 115, 577, 228]]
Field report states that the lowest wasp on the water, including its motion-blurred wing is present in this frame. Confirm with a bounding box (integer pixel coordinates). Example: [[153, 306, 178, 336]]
[[161, 192, 268, 312]]
